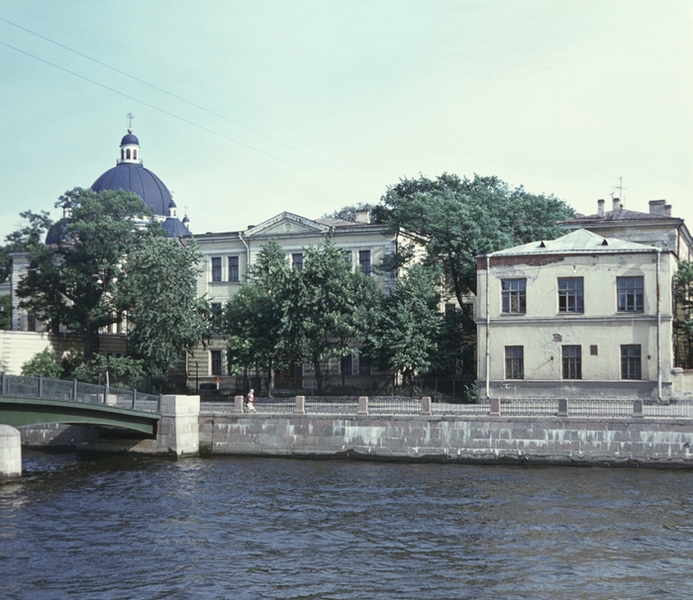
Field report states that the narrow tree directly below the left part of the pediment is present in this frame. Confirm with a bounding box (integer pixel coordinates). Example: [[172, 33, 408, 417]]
[[223, 241, 291, 396]]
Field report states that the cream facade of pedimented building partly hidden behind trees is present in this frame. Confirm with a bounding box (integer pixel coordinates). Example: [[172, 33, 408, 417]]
[[192, 211, 398, 390]]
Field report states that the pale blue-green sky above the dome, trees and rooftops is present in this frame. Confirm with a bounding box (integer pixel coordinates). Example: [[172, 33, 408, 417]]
[[0, 0, 693, 243]]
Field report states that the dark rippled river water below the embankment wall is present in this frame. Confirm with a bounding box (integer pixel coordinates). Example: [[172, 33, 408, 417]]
[[0, 450, 693, 600]]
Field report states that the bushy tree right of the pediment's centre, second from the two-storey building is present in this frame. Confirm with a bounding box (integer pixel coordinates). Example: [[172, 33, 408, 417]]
[[280, 241, 378, 390]]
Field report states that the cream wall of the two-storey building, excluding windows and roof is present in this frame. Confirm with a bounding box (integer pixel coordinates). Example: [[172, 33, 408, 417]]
[[477, 252, 676, 397]]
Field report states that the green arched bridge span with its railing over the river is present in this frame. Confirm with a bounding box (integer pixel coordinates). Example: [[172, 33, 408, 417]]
[[0, 373, 161, 438]]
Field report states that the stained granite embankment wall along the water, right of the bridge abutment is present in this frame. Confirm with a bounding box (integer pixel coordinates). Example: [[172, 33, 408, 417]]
[[200, 414, 693, 467]]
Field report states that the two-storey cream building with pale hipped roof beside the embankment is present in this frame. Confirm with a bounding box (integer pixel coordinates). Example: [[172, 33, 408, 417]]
[[477, 229, 677, 399]]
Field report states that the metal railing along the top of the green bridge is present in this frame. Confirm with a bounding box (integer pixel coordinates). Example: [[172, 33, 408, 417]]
[[0, 373, 161, 412]]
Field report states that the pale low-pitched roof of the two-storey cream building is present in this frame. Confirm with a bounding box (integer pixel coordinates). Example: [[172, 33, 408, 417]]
[[489, 229, 653, 256]]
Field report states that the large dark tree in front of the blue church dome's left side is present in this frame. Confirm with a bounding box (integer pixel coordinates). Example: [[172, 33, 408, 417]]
[[14, 188, 157, 363]]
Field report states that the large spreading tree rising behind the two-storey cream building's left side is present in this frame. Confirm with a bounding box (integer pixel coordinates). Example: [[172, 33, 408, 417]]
[[373, 173, 575, 305]]
